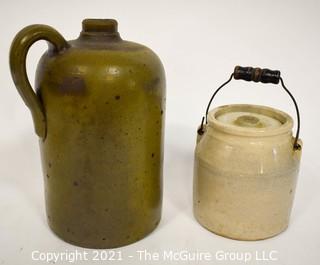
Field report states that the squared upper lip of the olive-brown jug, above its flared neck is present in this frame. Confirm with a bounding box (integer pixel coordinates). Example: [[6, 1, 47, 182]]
[[82, 18, 118, 34]]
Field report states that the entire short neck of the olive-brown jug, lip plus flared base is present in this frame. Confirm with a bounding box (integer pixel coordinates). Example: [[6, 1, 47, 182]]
[[80, 19, 121, 41]]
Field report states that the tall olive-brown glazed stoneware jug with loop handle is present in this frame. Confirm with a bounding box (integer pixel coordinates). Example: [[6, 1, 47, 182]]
[[10, 19, 165, 248]]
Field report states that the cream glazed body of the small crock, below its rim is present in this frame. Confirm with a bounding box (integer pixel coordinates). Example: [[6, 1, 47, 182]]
[[194, 126, 301, 240]]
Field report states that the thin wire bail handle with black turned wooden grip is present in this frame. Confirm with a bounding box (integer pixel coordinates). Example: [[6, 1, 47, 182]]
[[198, 66, 301, 150]]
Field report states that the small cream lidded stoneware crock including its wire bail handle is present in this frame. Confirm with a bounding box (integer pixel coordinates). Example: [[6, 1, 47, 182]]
[[194, 67, 301, 240]]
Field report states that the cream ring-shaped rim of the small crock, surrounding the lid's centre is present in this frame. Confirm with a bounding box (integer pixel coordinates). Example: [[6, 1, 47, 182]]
[[208, 104, 293, 137]]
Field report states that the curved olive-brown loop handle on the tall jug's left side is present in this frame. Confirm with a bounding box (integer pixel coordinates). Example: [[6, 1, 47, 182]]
[[10, 25, 69, 139]]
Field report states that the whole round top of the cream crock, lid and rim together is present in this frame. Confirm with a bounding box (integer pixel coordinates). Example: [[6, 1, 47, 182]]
[[208, 104, 293, 136]]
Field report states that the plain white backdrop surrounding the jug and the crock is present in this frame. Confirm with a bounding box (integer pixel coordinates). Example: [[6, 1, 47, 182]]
[[0, 0, 320, 265]]
